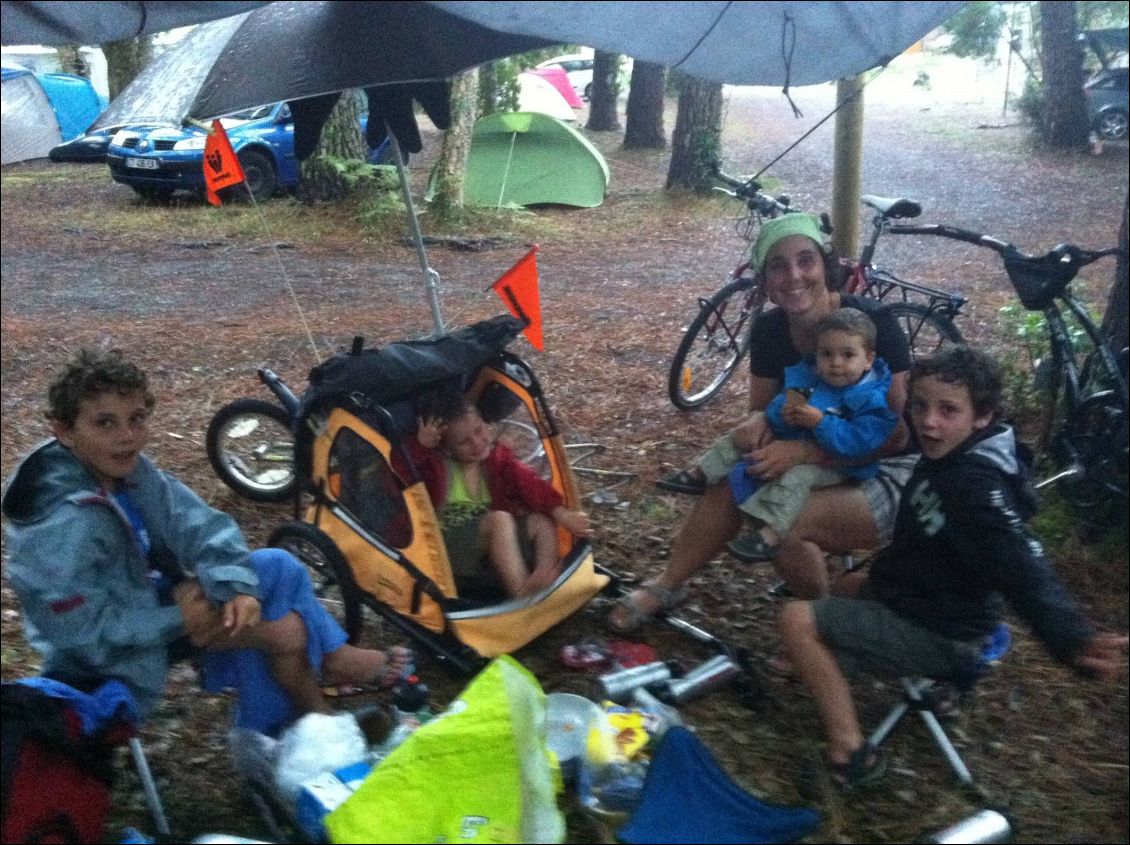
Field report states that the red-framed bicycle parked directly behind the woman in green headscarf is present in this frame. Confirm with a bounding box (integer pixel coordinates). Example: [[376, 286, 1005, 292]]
[[667, 176, 966, 410]]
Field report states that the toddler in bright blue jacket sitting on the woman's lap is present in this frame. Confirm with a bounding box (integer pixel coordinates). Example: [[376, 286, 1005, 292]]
[[698, 308, 898, 560]]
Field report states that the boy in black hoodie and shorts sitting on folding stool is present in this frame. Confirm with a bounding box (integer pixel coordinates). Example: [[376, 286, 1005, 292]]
[[780, 346, 1128, 787]]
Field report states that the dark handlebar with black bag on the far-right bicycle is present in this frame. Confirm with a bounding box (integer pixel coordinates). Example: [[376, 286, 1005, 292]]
[[887, 224, 1122, 311]]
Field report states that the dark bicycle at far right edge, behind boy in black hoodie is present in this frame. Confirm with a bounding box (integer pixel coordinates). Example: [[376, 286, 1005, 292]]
[[876, 225, 1128, 528]]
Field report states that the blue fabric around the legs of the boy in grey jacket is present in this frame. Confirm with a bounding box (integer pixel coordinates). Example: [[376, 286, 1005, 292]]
[[203, 549, 348, 735]]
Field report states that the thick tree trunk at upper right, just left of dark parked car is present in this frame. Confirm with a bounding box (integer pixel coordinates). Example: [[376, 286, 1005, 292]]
[[1040, 0, 1089, 147]]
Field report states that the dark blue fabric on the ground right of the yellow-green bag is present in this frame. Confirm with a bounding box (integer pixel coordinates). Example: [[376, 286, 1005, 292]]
[[616, 728, 820, 843]]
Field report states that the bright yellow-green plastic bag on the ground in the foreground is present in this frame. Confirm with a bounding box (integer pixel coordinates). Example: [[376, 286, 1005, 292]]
[[325, 655, 565, 843]]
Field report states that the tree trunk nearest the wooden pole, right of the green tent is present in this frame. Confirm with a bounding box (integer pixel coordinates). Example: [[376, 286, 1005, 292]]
[[667, 76, 722, 193]]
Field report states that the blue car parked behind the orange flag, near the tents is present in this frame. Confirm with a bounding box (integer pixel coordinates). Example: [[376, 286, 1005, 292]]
[[106, 103, 388, 202]]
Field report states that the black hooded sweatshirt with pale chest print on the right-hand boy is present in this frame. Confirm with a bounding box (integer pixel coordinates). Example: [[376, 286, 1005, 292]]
[[861, 423, 1095, 663]]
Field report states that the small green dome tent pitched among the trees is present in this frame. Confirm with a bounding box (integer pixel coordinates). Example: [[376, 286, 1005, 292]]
[[449, 112, 608, 208]]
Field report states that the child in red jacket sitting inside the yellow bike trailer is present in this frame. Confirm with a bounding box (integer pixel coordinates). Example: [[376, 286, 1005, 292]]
[[407, 398, 592, 598]]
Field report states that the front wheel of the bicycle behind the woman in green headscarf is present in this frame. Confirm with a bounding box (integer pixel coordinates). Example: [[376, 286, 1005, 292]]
[[667, 277, 765, 411]]
